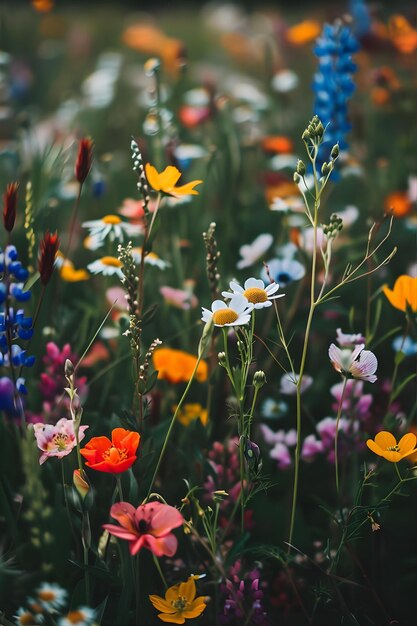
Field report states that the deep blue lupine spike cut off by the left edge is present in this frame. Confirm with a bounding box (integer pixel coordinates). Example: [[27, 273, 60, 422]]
[[0, 246, 35, 415]]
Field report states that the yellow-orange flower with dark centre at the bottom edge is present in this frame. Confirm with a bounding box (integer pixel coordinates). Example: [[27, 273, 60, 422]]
[[149, 576, 206, 624]]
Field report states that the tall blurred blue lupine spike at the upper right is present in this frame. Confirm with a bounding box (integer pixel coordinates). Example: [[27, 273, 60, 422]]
[[313, 24, 359, 170]]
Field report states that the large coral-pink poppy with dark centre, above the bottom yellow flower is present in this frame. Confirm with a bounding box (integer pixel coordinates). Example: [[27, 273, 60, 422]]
[[103, 502, 184, 556]]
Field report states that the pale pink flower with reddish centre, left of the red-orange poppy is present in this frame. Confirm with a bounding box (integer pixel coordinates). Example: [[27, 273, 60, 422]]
[[30, 417, 88, 465]]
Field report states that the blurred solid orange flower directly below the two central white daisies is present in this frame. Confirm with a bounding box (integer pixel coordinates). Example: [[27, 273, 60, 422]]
[[153, 348, 208, 384]]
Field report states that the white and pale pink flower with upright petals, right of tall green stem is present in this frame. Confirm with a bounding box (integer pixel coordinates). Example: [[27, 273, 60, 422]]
[[329, 343, 378, 383]]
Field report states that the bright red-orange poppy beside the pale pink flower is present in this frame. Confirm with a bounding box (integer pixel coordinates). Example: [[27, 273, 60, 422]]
[[80, 428, 140, 474]]
